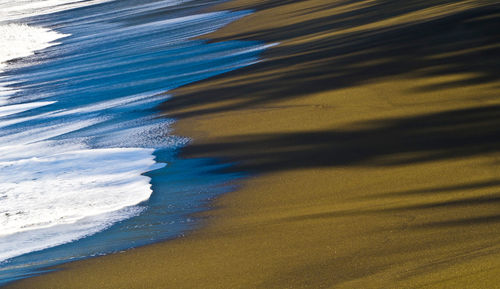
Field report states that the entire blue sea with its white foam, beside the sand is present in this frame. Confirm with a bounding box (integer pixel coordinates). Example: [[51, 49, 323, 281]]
[[0, 0, 268, 285]]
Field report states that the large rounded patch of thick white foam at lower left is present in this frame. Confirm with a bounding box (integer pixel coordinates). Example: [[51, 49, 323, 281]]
[[0, 115, 168, 262]]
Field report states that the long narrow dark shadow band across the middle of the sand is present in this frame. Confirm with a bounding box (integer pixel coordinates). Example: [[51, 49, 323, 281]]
[[185, 105, 500, 172]]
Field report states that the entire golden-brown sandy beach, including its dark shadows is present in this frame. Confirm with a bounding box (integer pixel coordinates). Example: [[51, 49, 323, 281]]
[[4, 0, 500, 289]]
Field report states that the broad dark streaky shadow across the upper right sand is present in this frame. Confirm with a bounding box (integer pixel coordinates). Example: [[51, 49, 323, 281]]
[[163, 0, 500, 118]]
